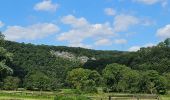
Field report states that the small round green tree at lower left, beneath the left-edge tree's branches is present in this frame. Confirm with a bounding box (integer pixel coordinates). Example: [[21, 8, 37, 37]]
[[3, 76, 20, 90]]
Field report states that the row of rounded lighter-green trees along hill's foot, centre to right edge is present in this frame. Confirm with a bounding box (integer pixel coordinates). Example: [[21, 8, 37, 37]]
[[67, 63, 170, 94]]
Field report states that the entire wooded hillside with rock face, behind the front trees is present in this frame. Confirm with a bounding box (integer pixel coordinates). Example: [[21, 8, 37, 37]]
[[0, 40, 170, 94]]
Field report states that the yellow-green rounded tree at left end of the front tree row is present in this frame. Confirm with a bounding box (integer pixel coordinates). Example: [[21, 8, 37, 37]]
[[67, 68, 100, 92]]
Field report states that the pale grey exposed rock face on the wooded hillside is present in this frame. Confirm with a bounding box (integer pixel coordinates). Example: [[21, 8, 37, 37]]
[[50, 50, 96, 63]]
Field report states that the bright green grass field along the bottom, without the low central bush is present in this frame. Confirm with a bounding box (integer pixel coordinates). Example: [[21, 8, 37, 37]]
[[0, 89, 170, 100]]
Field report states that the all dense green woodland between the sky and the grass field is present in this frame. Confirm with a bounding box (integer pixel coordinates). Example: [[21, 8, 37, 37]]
[[0, 34, 170, 94]]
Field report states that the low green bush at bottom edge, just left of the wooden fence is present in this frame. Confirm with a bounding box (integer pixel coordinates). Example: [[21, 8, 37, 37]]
[[54, 95, 91, 100]]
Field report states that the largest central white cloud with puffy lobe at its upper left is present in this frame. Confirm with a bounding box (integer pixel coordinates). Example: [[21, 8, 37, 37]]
[[57, 15, 115, 47]]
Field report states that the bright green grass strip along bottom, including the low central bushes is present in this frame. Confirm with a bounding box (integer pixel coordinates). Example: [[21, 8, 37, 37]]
[[0, 89, 170, 100]]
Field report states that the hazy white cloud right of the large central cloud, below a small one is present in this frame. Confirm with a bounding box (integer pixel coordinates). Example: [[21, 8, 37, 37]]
[[113, 14, 140, 32]]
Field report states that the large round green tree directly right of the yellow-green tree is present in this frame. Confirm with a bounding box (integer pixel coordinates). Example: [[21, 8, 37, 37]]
[[103, 63, 139, 92]]
